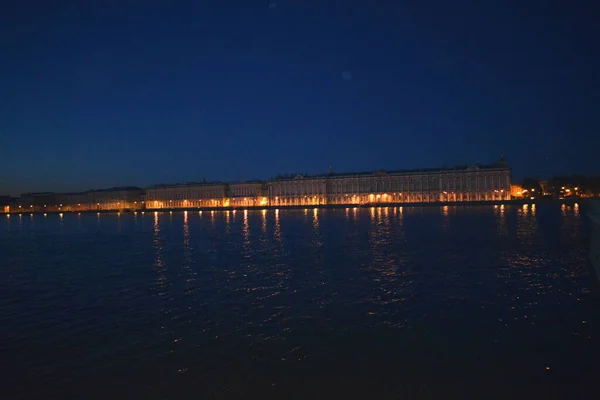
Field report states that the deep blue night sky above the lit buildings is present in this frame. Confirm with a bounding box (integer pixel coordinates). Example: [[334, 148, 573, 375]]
[[0, 0, 600, 195]]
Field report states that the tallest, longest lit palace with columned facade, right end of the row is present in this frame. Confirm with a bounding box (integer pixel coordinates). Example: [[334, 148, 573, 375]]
[[267, 160, 511, 206]]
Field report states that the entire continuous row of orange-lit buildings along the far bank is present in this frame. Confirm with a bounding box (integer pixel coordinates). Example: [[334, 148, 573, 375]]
[[3, 160, 510, 212]]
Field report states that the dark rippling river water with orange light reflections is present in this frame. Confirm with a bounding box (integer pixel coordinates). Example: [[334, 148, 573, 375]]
[[0, 205, 600, 399]]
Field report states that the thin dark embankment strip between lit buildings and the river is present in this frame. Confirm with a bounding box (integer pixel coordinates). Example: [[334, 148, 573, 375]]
[[0, 199, 592, 215]]
